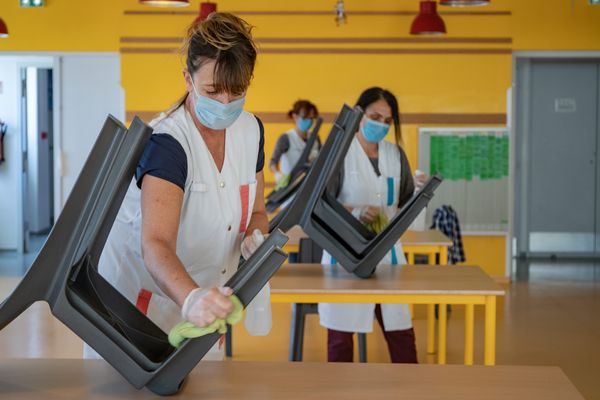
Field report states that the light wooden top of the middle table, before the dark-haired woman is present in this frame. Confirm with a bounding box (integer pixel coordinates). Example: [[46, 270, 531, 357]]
[[270, 264, 505, 296]]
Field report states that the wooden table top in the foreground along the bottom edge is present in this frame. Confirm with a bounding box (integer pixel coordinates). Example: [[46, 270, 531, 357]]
[[0, 359, 583, 400]]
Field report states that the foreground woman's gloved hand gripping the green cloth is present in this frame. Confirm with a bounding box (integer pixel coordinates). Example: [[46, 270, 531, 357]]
[[181, 287, 234, 328]]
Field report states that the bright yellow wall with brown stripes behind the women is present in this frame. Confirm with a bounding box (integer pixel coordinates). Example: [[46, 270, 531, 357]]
[[0, 0, 600, 275]]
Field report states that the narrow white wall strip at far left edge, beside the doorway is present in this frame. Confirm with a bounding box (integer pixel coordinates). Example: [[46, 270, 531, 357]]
[[0, 57, 21, 249]]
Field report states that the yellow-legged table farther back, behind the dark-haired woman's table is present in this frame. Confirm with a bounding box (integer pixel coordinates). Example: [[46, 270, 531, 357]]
[[284, 225, 450, 354]]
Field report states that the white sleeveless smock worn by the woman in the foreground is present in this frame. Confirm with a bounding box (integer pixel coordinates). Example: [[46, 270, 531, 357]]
[[84, 107, 270, 359]]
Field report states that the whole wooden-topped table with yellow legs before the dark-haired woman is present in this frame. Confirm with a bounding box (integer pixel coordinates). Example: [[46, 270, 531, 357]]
[[271, 264, 505, 365]]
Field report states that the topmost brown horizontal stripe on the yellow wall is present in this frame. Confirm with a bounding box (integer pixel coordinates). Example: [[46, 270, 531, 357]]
[[123, 10, 512, 17]]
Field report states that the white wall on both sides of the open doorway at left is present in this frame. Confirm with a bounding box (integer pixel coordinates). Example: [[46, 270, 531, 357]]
[[0, 53, 125, 250]]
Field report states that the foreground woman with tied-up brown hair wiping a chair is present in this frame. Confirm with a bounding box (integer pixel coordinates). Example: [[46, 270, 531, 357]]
[[86, 13, 270, 358]]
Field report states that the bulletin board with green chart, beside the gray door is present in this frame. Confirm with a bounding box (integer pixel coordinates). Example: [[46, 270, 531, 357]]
[[418, 127, 509, 233]]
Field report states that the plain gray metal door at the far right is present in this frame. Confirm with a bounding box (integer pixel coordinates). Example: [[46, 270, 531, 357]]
[[524, 60, 600, 255]]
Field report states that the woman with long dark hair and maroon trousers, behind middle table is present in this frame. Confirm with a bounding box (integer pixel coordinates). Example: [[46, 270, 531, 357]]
[[319, 87, 417, 363]]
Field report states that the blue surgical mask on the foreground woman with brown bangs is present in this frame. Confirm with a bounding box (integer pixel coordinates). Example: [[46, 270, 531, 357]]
[[192, 83, 246, 129]]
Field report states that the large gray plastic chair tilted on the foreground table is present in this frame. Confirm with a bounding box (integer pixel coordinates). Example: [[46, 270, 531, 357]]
[[0, 116, 287, 395]]
